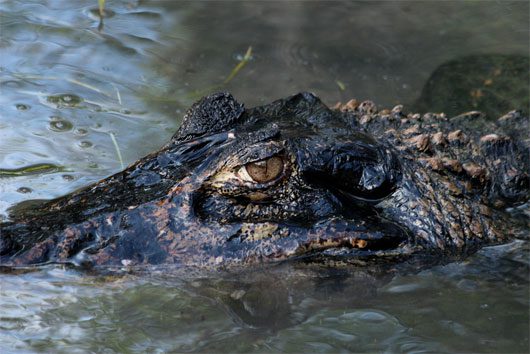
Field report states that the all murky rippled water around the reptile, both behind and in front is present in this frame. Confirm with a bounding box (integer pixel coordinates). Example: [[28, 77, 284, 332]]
[[0, 0, 529, 354]]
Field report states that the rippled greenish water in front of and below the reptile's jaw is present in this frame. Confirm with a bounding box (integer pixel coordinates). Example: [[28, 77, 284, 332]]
[[0, 242, 529, 353]]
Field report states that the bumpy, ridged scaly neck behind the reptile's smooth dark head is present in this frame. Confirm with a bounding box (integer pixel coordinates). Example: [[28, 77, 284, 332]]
[[337, 100, 529, 252]]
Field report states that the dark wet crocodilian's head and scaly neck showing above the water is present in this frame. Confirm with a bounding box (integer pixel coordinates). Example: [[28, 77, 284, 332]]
[[0, 93, 529, 269]]
